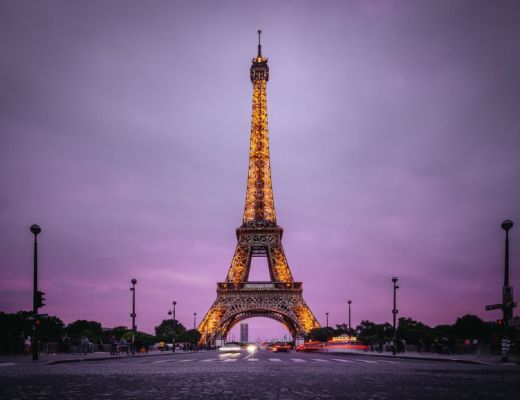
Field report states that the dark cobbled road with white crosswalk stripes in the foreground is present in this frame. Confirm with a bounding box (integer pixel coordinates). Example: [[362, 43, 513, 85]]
[[0, 351, 520, 400]]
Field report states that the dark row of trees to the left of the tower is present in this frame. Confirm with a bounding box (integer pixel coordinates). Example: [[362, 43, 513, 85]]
[[0, 311, 200, 354]]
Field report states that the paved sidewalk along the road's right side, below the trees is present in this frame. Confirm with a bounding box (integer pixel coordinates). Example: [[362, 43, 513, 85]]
[[327, 350, 518, 365]]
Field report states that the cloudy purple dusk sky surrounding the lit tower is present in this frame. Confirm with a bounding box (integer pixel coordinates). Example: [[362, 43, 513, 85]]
[[0, 0, 520, 338]]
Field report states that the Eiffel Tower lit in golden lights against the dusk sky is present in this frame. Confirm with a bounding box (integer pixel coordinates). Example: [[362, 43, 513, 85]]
[[198, 31, 320, 343]]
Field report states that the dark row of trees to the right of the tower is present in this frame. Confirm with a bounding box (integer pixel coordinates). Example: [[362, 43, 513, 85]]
[[307, 314, 517, 351]]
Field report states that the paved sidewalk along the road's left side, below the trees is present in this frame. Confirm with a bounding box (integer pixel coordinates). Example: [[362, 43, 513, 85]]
[[0, 350, 195, 366]]
